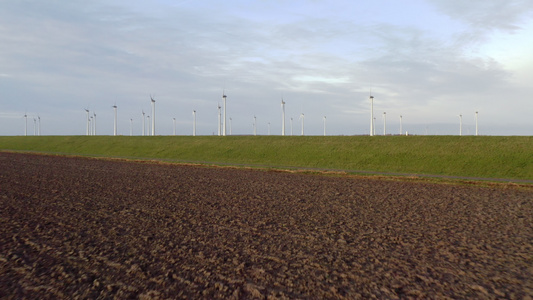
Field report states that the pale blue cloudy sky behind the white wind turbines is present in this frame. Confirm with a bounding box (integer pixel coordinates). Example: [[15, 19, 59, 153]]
[[0, 0, 533, 135]]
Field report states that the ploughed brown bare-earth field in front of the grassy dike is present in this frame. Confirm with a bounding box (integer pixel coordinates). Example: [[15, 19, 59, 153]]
[[0, 152, 533, 299]]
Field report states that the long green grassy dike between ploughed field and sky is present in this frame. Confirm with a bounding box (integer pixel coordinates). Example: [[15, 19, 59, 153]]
[[0, 136, 533, 180]]
